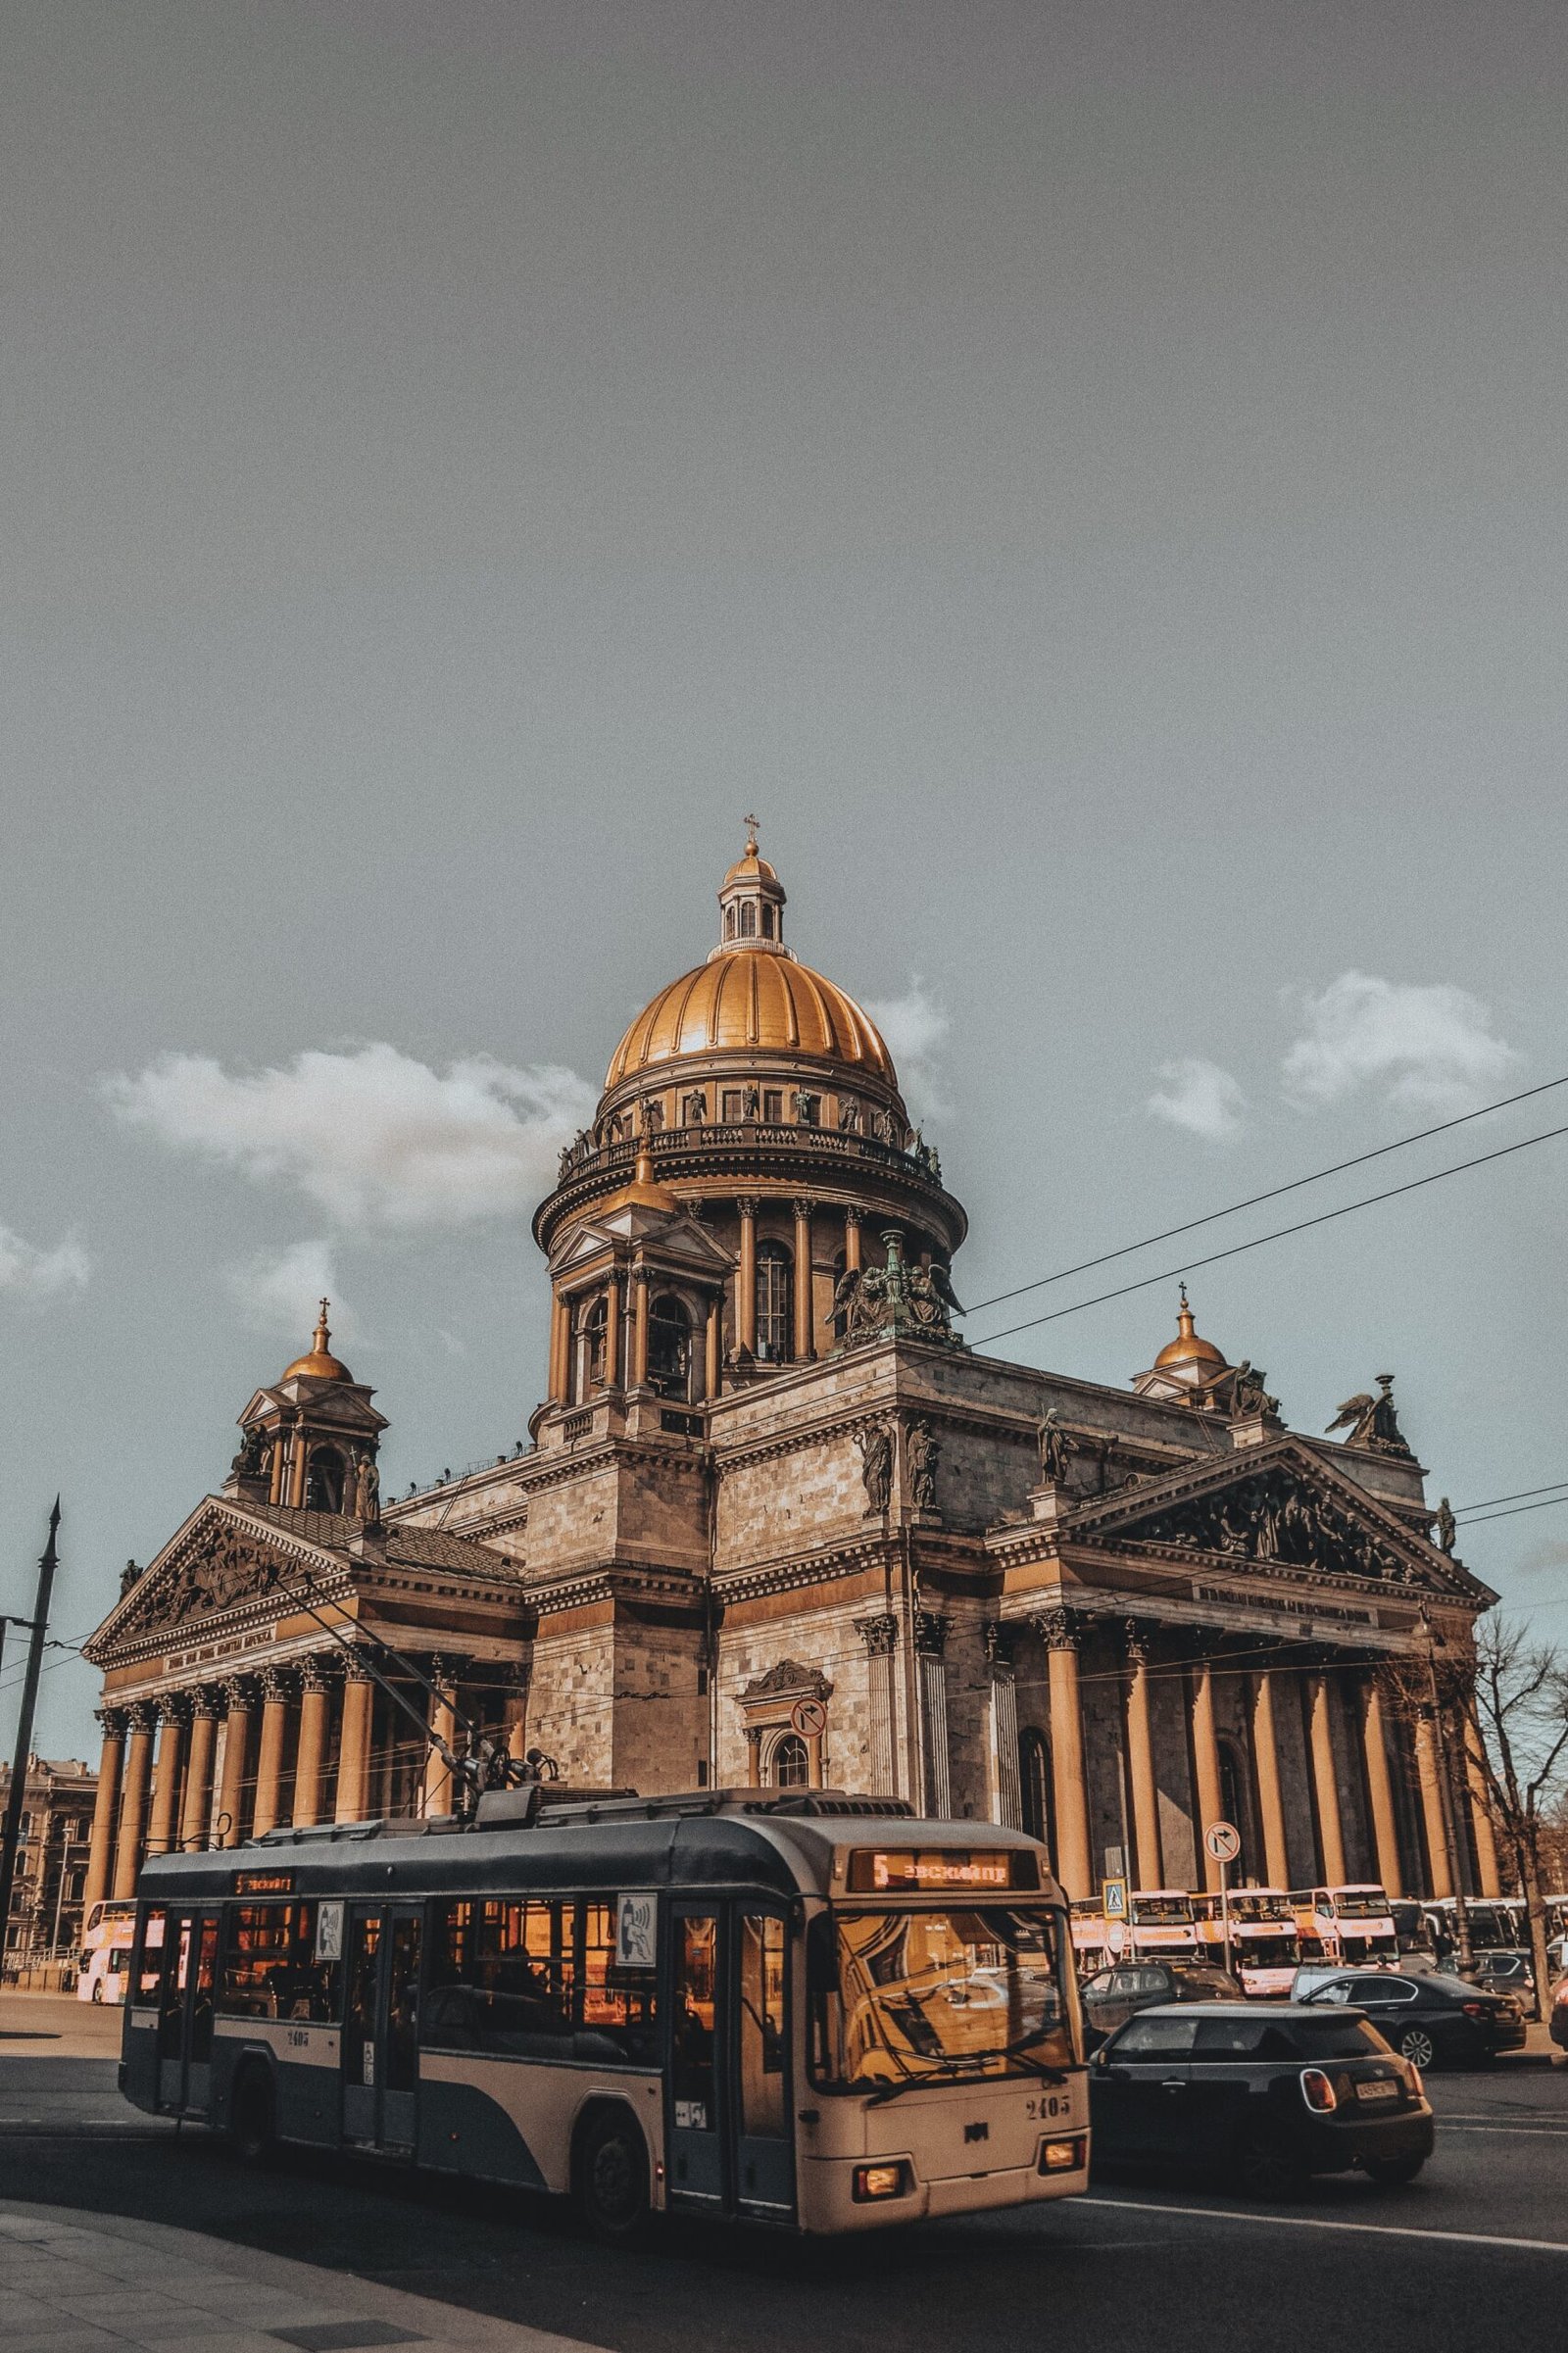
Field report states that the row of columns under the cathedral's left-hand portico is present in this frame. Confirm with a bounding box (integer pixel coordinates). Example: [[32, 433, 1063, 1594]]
[[82, 1649, 527, 1908]]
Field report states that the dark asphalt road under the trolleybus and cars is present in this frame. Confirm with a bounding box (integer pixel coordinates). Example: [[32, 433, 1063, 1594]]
[[0, 2047, 1568, 2353]]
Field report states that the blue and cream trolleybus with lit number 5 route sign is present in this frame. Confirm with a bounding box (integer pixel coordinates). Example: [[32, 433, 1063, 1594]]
[[122, 1784, 1088, 2240]]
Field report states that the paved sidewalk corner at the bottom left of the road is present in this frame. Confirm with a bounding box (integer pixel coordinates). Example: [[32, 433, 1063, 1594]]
[[0, 2200, 593, 2353]]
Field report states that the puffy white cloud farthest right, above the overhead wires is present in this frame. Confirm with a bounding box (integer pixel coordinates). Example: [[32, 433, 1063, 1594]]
[[1283, 972, 1521, 1115]]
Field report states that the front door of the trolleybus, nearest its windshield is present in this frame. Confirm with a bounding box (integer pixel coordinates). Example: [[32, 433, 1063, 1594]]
[[666, 1901, 796, 2222]]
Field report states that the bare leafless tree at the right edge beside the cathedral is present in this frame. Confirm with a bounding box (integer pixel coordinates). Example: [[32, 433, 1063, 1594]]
[[1455, 1616, 1568, 2017]]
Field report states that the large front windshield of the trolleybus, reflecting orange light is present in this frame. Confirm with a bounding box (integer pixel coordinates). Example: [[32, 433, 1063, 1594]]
[[812, 1906, 1076, 2087]]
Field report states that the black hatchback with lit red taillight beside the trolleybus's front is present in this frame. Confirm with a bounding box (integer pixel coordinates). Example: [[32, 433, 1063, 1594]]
[[1090, 2002, 1432, 2198]]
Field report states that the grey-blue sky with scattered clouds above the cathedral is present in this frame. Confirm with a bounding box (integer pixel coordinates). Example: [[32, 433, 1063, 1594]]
[[0, 0, 1568, 1753]]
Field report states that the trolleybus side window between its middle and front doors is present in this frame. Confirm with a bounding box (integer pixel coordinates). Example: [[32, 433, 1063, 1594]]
[[421, 1896, 655, 2064]]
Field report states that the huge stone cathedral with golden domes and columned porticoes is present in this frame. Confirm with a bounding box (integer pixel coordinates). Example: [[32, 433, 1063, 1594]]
[[84, 838, 1497, 1903]]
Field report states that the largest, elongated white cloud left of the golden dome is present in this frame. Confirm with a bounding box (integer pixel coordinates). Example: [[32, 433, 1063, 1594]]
[[104, 1045, 596, 1248]]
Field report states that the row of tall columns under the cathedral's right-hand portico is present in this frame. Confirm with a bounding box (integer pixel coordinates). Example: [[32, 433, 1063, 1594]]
[[969, 1607, 1499, 1896]]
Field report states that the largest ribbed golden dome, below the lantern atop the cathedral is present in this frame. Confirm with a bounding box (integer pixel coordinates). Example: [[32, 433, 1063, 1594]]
[[605, 944, 897, 1092]]
